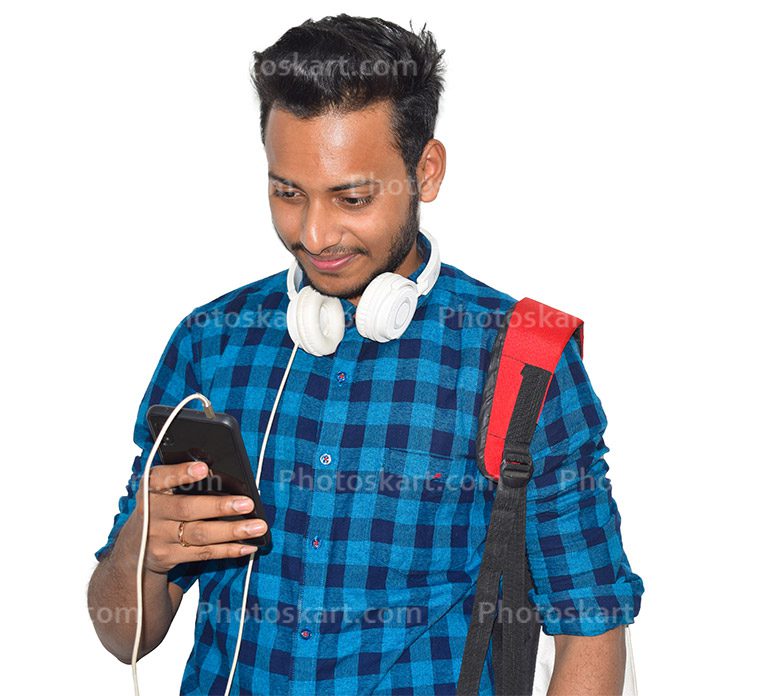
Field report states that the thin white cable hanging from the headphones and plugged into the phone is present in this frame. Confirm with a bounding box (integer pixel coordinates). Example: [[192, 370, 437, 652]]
[[131, 343, 298, 696]]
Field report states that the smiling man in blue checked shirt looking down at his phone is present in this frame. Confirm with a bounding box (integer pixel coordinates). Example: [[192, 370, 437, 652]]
[[89, 15, 644, 696]]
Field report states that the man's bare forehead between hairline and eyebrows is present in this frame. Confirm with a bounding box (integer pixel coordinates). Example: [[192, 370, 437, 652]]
[[265, 102, 404, 187]]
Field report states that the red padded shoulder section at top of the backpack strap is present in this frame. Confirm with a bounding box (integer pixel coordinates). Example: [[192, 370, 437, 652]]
[[476, 297, 583, 481]]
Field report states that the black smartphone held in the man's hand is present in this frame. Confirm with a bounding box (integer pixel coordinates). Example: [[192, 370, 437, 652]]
[[147, 404, 270, 546]]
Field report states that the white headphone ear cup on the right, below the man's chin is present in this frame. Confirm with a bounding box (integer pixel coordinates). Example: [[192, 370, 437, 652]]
[[356, 273, 418, 343]]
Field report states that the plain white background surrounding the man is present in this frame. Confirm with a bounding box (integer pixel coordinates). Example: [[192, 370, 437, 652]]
[[0, 0, 770, 694]]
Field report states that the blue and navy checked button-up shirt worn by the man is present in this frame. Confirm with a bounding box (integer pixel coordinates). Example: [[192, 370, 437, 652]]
[[96, 235, 644, 695]]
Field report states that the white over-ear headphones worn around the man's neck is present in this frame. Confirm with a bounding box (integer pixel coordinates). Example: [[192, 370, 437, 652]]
[[286, 230, 441, 355]]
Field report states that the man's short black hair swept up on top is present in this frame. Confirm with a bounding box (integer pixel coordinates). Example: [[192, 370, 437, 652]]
[[251, 14, 444, 178]]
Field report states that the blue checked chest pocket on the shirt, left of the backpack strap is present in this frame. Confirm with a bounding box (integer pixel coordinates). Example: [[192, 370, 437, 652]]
[[370, 448, 476, 581]]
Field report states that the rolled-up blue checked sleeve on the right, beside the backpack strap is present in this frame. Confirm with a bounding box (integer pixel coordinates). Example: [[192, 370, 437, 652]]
[[527, 337, 644, 635]]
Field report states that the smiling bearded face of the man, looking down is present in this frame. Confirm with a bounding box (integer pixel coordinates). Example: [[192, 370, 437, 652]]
[[265, 102, 420, 304]]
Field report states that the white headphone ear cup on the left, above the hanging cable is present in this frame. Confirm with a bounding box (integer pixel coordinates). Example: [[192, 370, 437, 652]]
[[286, 285, 345, 356]]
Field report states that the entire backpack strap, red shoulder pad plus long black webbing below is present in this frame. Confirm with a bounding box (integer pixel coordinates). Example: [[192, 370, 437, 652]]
[[457, 298, 583, 696]]
